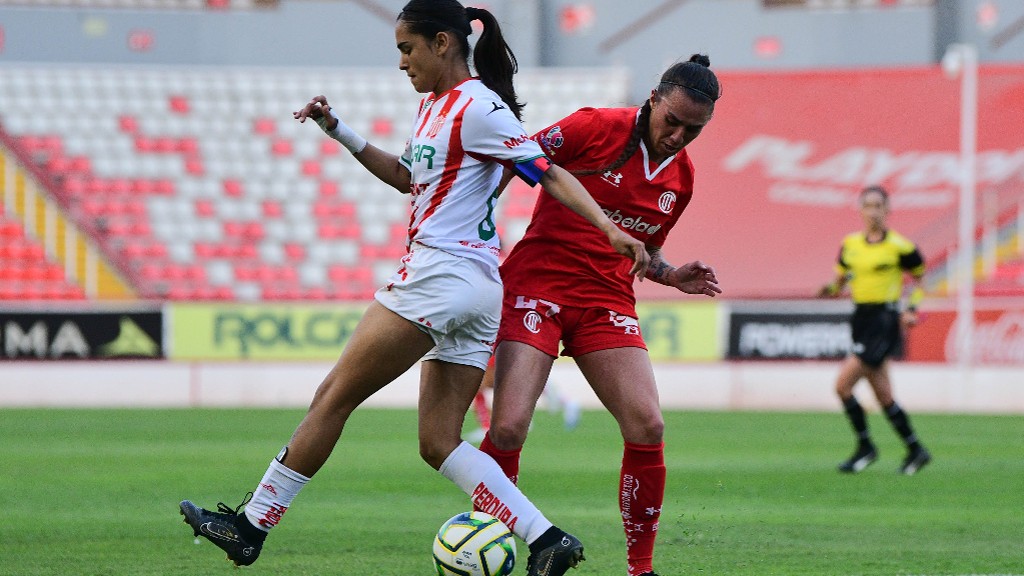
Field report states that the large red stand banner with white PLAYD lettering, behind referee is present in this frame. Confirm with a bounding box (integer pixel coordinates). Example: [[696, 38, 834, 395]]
[[637, 66, 1024, 298]]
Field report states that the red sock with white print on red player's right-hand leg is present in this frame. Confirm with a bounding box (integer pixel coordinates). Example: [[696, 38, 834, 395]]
[[618, 442, 665, 576]]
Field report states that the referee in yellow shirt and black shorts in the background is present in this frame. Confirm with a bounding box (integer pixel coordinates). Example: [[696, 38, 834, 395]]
[[818, 187, 932, 475]]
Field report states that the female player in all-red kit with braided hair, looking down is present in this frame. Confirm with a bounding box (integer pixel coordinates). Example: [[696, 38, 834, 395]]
[[480, 54, 721, 576]]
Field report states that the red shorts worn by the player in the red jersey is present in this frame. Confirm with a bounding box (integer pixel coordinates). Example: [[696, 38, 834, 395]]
[[497, 294, 647, 357]]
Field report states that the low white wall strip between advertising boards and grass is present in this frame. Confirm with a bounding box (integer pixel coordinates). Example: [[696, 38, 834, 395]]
[[0, 360, 1024, 414]]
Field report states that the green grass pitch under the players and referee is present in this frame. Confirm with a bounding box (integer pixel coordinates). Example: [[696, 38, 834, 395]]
[[0, 409, 1024, 576]]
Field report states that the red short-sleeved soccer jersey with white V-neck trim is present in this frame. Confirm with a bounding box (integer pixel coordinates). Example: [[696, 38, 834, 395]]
[[501, 108, 693, 318]]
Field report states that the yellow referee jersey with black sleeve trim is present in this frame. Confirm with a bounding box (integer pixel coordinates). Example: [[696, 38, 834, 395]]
[[836, 230, 925, 304]]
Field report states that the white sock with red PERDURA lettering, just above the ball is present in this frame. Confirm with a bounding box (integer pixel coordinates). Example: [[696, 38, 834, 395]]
[[438, 442, 552, 544]]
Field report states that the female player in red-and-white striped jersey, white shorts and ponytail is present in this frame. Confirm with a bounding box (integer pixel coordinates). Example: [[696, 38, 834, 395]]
[[173, 0, 649, 576]]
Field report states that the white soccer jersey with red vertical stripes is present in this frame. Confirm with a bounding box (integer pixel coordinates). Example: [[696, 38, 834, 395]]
[[401, 78, 550, 266]]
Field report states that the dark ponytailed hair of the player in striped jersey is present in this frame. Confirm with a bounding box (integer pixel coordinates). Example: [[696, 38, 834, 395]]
[[398, 0, 525, 120]]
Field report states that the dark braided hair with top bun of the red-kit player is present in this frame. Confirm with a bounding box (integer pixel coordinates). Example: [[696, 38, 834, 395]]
[[572, 54, 722, 176]]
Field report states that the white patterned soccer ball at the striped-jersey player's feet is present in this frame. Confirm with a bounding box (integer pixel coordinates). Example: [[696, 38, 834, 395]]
[[434, 512, 515, 576]]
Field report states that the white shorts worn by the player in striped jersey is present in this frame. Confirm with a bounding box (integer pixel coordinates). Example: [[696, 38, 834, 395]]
[[374, 244, 502, 370]]
